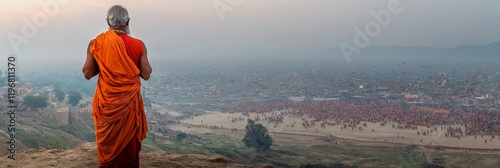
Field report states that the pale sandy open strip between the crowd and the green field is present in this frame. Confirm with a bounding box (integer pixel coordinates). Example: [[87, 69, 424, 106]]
[[181, 112, 500, 150]]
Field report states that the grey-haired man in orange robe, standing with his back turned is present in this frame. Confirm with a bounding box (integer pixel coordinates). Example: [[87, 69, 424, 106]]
[[82, 5, 152, 167]]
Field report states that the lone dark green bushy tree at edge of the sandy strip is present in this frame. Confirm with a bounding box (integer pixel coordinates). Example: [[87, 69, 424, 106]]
[[243, 119, 273, 151]]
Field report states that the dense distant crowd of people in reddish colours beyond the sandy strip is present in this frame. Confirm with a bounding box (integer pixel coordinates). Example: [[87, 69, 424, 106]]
[[226, 98, 500, 136]]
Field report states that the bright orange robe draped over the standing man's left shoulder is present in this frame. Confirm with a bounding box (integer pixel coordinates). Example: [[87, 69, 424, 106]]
[[90, 31, 147, 166]]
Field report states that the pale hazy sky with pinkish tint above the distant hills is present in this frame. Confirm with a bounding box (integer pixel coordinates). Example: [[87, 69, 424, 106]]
[[0, 0, 500, 60]]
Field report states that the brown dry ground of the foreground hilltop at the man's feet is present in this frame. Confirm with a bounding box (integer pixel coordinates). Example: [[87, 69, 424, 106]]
[[0, 143, 271, 168]]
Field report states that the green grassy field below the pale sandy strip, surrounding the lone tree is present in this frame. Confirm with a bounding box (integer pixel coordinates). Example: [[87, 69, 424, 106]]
[[170, 121, 500, 167]]
